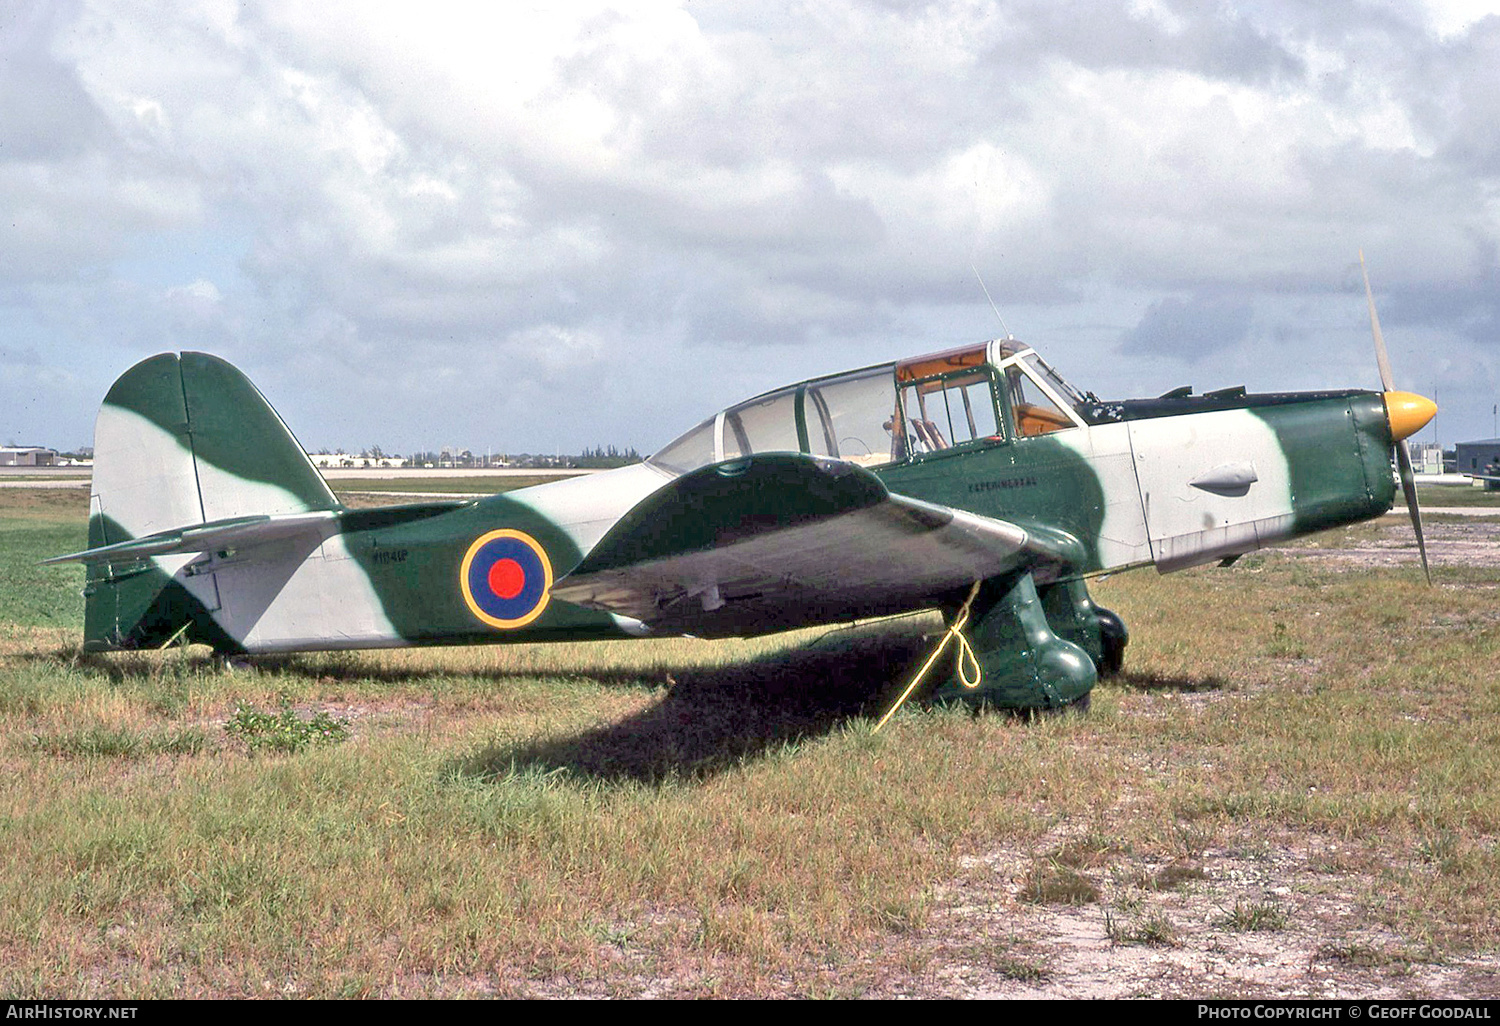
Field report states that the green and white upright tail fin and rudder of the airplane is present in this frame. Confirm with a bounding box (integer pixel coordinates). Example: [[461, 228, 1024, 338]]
[[84, 353, 339, 650]]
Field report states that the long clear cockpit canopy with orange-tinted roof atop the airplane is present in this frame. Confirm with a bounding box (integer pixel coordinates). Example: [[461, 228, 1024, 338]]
[[648, 339, 1086, 474]]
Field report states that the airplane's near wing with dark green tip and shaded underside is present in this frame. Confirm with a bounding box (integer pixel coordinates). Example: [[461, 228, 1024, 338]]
[[552, 453, 1082, 638]]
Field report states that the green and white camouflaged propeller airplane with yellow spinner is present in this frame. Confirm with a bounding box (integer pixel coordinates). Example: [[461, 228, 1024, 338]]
[[47, 279, 1437, 711]]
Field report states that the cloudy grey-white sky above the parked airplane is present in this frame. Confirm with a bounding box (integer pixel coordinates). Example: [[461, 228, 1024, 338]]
[[0, 0, 1500, 453]]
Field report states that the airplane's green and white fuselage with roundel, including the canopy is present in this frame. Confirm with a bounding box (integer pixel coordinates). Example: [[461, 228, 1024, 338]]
[[218, 344, 1394, 651]]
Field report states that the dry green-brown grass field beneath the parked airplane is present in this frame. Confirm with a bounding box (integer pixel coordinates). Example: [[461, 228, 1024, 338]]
[[0, 491, 1500, 998]]
